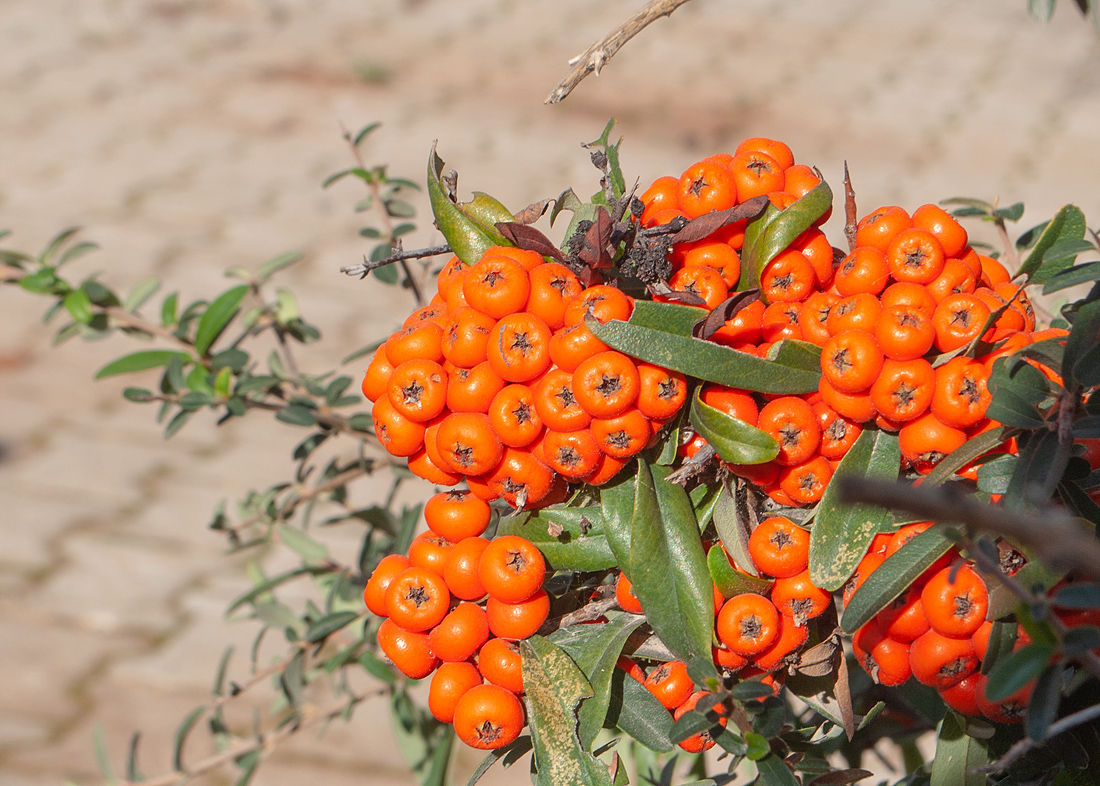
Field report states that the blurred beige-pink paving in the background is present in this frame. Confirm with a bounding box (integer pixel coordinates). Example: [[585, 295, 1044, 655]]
[[0, 0, 1100, 786]]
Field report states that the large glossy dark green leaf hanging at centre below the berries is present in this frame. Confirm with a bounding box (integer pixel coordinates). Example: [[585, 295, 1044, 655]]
[[604, 462, 714, 661]]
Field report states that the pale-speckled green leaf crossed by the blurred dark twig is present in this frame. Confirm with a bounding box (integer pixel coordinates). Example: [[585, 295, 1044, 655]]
[[810, 429, 901, 591]]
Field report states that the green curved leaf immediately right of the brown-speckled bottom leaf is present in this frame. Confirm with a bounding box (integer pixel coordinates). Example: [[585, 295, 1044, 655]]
[[550, 615, 642, 751]]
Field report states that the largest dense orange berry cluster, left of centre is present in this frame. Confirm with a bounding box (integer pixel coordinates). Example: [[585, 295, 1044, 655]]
[[363, 246, 688, 508]]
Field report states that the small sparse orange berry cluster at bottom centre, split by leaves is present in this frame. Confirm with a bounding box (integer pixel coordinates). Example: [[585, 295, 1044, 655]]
[[615, 516, 833, 753]]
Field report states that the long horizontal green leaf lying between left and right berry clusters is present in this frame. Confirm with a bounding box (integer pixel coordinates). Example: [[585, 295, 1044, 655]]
[[585, 319, 821, 394]]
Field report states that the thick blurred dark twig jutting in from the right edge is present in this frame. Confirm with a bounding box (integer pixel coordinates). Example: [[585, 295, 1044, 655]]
[[838, 476, 1100, 580]]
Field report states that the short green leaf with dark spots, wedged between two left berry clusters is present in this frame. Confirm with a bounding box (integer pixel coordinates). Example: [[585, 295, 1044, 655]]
[[496, 508, 618, 571]]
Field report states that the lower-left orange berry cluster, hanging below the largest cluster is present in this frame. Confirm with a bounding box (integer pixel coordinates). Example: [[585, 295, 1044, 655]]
[[363, 490, 550, 750]]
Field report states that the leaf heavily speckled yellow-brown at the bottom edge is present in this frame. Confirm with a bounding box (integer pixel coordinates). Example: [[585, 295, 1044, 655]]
[[519, 635, 611, 786]]
